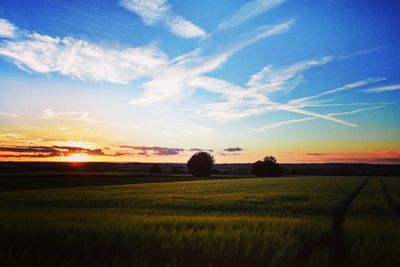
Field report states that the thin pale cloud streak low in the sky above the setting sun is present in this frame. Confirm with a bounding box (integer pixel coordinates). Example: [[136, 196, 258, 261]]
[[39, 108, 139, 129]]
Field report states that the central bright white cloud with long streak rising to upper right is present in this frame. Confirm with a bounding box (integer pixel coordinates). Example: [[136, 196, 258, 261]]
[[131, 20, 293, 105]]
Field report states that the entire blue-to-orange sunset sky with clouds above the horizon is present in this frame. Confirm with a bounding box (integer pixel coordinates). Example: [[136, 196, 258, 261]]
[[0, 0, 400, 164]]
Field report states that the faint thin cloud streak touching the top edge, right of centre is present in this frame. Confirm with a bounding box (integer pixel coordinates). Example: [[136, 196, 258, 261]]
[[218, 0, 285, 29]]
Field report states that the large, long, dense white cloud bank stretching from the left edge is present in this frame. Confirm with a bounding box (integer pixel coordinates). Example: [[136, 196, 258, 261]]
[[0, 33, 168, 84]]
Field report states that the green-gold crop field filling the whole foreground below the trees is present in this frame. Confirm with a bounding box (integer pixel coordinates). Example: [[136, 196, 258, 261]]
[[0, 175, 400, 266]]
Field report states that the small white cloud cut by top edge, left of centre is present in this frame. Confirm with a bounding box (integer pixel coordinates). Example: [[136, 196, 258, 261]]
[[120, 0, 206, 39]]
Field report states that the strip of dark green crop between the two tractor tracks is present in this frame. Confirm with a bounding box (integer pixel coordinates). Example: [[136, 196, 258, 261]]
[[343, 178, 400, 266]]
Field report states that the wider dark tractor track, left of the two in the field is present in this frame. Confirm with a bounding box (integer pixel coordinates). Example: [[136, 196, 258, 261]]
[[288, 179, 369, 267]]
